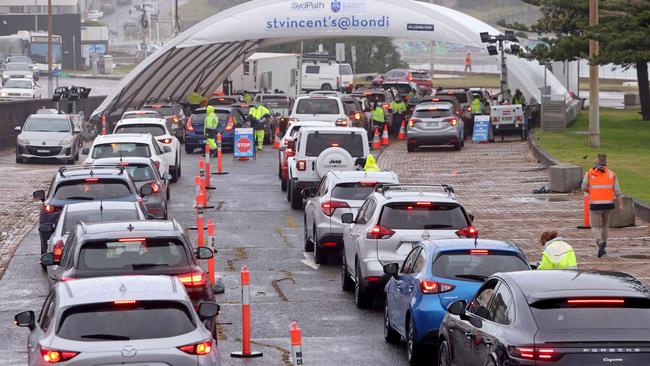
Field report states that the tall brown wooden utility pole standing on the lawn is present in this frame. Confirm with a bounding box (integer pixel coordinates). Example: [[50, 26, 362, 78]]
[[589, 0, 600, 148]]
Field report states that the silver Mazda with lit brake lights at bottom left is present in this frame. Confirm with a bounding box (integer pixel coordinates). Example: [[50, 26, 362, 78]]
[[15, 276, 221, 366]]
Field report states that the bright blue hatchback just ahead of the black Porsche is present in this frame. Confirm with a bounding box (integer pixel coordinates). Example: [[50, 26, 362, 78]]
[[384, 239, 530, 365]]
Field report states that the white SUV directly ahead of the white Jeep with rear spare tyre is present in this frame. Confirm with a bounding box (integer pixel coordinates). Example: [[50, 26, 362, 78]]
[[289, 95, 352, 127]]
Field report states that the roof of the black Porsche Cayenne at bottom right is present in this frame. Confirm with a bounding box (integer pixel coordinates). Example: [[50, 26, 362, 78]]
[[499, 270, 650, 303]]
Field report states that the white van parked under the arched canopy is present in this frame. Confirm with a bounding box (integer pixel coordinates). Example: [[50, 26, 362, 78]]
[[302, 62, 354, 90]]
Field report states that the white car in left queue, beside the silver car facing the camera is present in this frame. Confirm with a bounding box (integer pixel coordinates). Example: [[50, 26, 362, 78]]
[[82, 133, 172, 176]]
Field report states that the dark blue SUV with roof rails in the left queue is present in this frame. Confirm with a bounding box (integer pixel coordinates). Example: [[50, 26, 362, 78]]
[[32, 165, 152, 260]]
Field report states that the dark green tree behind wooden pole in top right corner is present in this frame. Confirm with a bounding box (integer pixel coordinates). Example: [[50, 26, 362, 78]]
[[499, 0, 650, 121]]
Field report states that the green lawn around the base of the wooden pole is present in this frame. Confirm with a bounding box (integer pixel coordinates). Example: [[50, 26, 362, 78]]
[[535, 109, 650, 202]]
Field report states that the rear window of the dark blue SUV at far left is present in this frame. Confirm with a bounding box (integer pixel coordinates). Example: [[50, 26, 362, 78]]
[[52, 178, 133, 201]]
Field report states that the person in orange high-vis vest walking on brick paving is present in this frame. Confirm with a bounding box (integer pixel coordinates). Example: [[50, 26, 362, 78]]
[[582, 154, 623, 258]]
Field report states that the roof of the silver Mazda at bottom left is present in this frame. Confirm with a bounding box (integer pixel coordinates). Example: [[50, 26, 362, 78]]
[[54, 275, 187, 307]]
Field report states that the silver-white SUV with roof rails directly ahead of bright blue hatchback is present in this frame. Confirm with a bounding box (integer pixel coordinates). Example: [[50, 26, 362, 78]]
[[341, 185, 478, 308]]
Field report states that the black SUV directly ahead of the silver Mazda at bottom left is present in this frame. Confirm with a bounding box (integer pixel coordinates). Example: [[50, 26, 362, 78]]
[[41, 220, 214, 306]]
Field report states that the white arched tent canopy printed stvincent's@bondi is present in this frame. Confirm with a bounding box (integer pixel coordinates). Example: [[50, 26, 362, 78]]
[[93, 0, 566, 116]]
